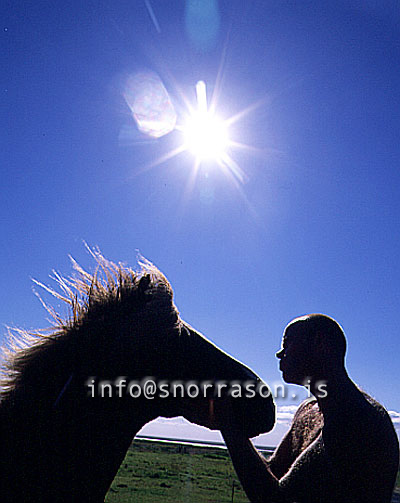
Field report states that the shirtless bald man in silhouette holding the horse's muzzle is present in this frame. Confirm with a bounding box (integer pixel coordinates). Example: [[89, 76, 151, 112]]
[[219, 314, 399, 503]]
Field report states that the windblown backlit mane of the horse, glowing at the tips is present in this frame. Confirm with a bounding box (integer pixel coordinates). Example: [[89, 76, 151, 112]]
[[0, 248, 181, 401]]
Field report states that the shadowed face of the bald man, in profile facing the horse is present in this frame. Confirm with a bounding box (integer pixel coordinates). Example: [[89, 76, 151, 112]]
[[276, 325, 313, 385]]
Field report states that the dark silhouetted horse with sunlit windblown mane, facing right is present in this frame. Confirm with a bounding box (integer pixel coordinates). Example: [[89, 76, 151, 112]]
[[0, 250, 275, 503]]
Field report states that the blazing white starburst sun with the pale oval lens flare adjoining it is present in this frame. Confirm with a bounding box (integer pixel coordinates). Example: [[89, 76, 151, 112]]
[[124, 77, 259, 187]]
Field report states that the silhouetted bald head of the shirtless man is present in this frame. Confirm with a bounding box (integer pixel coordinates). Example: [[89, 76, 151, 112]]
[[276, 314, 346, 384]]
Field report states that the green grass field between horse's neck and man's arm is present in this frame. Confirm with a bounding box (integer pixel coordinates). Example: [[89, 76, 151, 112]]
[[106, 440, 400, 503]]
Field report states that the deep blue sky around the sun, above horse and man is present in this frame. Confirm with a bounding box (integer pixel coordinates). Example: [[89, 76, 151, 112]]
[[0, 0, 400, 443]]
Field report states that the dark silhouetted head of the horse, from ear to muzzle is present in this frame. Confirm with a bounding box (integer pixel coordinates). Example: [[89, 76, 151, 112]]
[[80, 256, 275, 437]]
